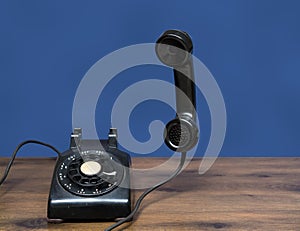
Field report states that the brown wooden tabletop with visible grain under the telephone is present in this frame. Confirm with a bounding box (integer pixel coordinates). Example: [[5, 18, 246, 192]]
[[0, 158, 300, 230]]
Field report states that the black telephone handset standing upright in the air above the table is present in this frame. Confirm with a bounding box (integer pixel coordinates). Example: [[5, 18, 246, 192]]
[[155, 30, 199, 152]]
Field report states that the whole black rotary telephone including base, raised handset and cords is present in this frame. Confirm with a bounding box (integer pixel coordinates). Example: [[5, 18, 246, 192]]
[[0, 30, 198, 230]]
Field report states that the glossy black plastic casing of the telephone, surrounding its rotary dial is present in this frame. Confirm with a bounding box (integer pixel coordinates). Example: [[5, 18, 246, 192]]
[[47, 140, 132, 221]]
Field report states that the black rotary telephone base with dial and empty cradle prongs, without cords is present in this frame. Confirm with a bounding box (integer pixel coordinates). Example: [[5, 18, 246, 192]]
[[47, 129, 132, 222]]
